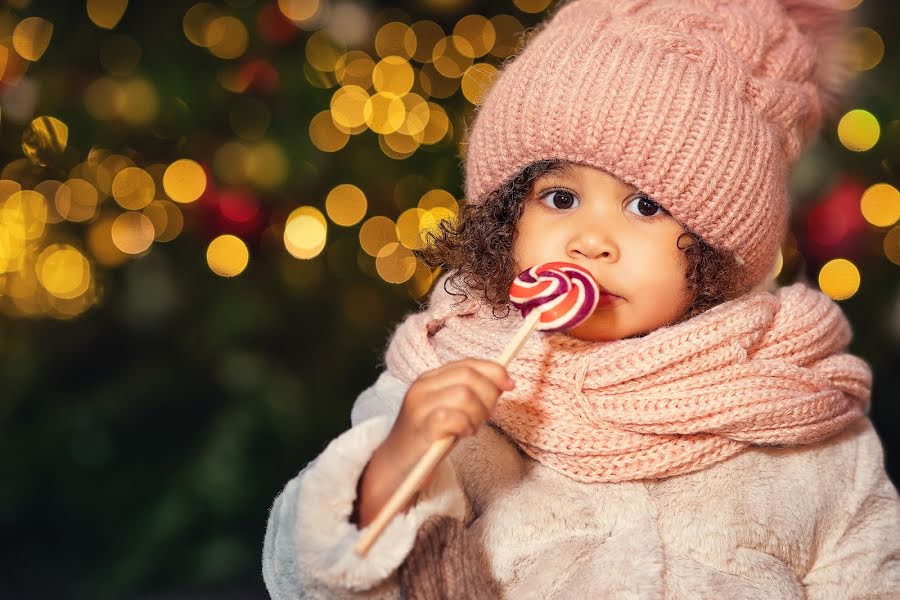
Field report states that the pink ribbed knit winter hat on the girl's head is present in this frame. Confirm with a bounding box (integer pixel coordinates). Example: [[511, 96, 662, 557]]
[[465, 0, 849, 288]]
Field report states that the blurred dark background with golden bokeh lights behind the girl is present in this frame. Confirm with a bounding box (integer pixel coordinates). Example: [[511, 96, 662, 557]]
[[0, 0, 900, 598]]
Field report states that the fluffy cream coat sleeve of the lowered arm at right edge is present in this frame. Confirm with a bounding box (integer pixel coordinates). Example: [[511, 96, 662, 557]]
[[803, 419, 900, 600]]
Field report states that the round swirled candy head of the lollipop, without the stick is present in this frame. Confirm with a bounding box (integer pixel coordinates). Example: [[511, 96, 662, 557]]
[[509, 262, 600, 331]]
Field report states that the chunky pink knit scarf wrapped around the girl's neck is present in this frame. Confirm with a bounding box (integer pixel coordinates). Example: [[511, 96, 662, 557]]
[[386, 280, 871, 482]]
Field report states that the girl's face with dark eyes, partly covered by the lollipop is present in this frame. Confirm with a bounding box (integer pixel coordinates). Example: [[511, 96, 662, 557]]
[[513, 164, 692, 341]]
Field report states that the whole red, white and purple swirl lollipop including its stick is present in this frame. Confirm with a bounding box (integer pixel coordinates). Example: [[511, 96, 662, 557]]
[[355, 262, 600, 556]]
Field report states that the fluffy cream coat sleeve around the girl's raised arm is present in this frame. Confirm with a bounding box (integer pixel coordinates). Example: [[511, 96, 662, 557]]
[[262, 372, 467, 600]]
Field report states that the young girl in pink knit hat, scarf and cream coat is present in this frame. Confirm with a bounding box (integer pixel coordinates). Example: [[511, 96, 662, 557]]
[[263, 0, 900, 599]]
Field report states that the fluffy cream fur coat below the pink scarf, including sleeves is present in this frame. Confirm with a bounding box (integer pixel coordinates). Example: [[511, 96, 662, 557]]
[[262, 372, 900, 600]]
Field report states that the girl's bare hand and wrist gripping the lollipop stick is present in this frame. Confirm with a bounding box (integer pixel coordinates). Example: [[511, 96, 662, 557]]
[[354, 358, 514, 527]]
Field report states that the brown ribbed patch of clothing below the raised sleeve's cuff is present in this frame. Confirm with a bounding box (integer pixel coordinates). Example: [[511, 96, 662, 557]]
[[398, 515, 500, 600]]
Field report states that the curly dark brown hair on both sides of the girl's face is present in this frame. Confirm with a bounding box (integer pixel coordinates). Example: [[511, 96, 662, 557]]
[[416, 159, 739, 322]]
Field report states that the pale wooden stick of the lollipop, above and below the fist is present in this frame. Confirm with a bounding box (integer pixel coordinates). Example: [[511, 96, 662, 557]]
[[354, 310, 541, 556]]
